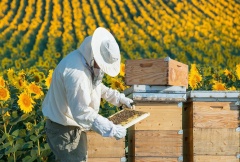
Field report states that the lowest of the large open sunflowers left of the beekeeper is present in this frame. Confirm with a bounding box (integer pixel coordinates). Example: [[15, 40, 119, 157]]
[[17, 91, 35, 113]]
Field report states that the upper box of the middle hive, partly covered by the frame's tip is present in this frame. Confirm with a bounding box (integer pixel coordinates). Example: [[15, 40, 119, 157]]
[[134, 102, 182, 130]]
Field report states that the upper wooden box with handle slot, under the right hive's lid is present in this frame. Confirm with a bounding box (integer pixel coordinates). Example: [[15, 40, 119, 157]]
[[183, 102, 240, 129]]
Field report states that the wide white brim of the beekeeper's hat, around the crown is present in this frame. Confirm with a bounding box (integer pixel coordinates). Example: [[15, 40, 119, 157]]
[[91, 27, 121, 77]]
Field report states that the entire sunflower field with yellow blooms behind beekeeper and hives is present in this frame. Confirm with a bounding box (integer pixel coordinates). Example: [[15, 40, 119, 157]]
[[0, 0, 240, 162]]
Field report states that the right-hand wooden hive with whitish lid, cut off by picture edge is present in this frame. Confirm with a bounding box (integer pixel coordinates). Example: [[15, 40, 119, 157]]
[[183, 91, 240, 162]]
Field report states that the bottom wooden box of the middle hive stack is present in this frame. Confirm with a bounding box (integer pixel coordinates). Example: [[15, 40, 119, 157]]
[[128, 129, 183, 162]]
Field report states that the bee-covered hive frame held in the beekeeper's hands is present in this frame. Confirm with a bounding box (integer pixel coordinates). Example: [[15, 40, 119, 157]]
[[108, 108, 150, 128]]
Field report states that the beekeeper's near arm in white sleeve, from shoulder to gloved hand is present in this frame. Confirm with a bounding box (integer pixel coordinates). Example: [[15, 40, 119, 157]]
[[64, 73, 126, 139]]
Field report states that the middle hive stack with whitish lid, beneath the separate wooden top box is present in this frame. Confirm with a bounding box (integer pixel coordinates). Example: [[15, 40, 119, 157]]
[[125, 85, 186, 162]]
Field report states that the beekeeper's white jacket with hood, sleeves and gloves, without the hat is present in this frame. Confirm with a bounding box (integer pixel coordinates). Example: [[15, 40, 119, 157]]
[[42, 27, 132, 139]]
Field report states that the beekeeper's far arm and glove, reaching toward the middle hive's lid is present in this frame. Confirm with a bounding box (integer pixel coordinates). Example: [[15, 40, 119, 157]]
[[101, 83, 133, 108]]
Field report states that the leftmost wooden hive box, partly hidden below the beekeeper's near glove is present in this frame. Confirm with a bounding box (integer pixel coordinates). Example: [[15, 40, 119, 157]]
[[87, 131, 125, 162]]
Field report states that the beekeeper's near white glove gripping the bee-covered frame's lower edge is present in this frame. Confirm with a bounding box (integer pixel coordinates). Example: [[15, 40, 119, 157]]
[[92, 115, 126, 140]]
